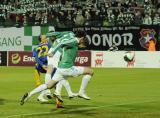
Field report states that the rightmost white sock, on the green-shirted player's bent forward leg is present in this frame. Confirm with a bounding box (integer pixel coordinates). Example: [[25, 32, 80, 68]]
[[79, 75, 92, 94]]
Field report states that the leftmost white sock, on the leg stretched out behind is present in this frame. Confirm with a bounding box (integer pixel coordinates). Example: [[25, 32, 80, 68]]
[[29, 84, 47, 97]]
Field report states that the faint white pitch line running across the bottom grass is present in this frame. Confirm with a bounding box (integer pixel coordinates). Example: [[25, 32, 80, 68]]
[[0, 101, 159, 118]]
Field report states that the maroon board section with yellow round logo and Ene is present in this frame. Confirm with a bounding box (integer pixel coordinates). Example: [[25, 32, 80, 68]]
[[8, 51, 35, 66]]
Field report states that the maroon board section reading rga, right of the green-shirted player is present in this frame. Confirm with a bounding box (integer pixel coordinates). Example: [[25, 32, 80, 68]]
[[75, 51, 91, 67]]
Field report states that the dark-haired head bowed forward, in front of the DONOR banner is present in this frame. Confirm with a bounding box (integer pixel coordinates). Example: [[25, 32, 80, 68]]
[[75, 31, 89, 48]]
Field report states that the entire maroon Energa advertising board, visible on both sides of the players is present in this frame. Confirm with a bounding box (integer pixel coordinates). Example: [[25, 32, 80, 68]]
[[8, 51, 91, 66]]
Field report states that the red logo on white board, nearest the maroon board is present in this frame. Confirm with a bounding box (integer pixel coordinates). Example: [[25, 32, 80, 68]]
[[95, 52, 103, 67]]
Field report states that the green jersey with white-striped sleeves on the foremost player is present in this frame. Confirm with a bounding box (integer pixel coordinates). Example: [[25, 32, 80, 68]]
[[46, 32, 79, 68]]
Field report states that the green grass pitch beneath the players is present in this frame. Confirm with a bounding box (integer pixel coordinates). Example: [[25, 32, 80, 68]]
[[0, 67, 160, 118]]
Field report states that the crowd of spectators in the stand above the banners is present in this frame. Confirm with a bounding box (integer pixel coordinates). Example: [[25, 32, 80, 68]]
[[0, 0, 160, 28]]
